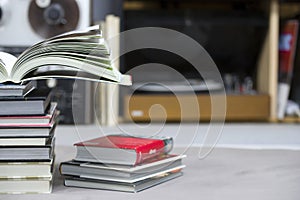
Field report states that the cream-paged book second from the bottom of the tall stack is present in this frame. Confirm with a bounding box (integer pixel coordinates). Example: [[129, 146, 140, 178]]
[[0, 159, 54, 179]]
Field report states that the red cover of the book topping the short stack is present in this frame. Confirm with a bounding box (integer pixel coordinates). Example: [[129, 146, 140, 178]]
[[74, 135, 166, 164]]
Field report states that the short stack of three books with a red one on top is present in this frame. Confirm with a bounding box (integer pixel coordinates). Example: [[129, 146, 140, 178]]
[[60, 135, 185, 192]]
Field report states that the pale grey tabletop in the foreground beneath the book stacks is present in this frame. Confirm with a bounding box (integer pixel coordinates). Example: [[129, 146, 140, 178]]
[[0, 124, 300, 200]]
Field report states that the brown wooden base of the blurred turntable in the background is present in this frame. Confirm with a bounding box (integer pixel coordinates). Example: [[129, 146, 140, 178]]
[[124, 94, 270, 122]]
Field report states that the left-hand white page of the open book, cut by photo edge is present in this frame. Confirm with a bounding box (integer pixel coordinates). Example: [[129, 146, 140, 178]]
[[0, 52, 17, 80]]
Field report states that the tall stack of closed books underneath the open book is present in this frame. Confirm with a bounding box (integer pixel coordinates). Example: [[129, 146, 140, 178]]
[[0, 82, 59, 193]]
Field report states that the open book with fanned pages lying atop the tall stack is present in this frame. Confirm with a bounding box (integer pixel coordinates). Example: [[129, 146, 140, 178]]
[[0, 25, 131, 85]]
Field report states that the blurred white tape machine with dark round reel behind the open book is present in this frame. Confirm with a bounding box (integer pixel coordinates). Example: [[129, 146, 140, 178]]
[[0, 0, 91, 47]]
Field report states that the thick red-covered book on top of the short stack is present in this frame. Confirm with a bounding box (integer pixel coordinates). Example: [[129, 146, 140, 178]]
[[74, 135, 173, 165]]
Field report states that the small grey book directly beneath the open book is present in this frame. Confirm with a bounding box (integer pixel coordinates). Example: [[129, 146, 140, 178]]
[[0, 81, 35, 97]]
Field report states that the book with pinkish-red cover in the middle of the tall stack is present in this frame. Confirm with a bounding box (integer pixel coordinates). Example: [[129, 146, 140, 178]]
[[0, 102, 59, 125]]
